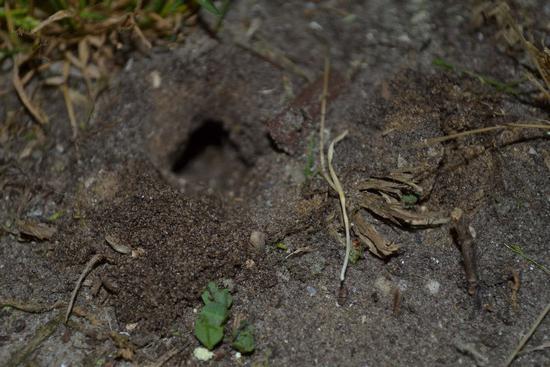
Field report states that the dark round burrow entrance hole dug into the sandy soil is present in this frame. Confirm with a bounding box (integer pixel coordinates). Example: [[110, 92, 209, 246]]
[[172, 119, 251, 192]]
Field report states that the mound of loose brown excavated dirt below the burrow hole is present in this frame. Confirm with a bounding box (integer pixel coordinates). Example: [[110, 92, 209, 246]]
[[56, 163, 276, 332]]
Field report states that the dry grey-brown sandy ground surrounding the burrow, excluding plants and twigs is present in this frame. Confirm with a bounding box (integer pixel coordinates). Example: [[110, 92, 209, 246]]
[[0, 0, 550, 366]]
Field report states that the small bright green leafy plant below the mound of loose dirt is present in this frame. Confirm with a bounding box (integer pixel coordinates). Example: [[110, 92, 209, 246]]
[[195, 282, 255, 354]]
